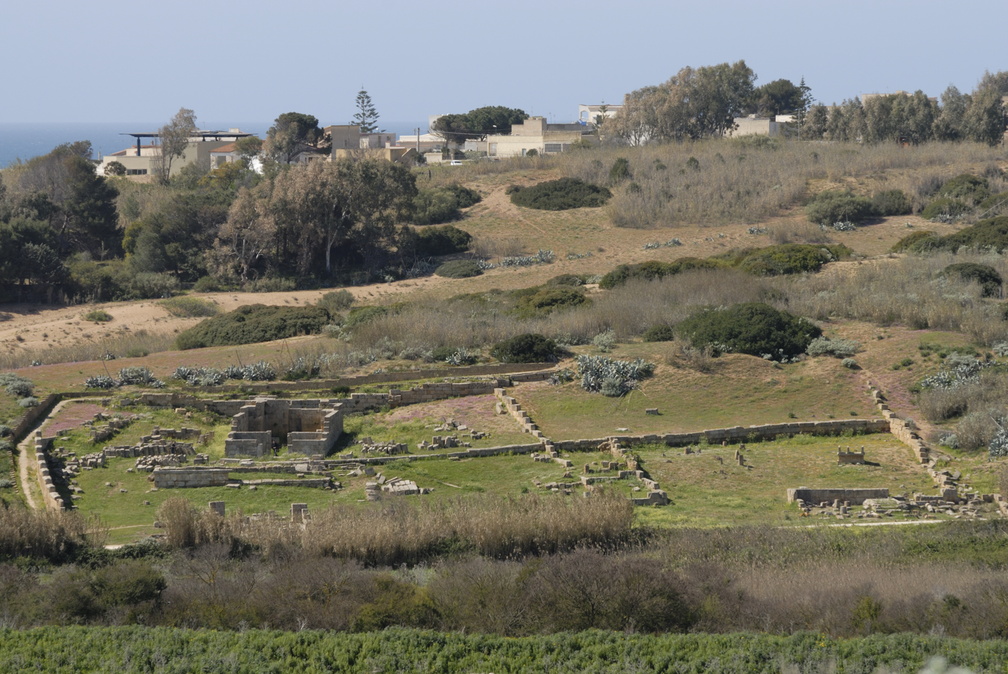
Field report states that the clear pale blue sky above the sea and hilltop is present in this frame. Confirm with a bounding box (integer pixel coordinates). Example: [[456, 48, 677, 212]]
[[0, 0, 1008, 124]]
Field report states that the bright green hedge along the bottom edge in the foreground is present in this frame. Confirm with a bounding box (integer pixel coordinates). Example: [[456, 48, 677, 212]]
[[0, 627, 1008, 674]]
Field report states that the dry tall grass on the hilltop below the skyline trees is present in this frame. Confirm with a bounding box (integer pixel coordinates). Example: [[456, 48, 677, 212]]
[[451, 138, 1001, 228]]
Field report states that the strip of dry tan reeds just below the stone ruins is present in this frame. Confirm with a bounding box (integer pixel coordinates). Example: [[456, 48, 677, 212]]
[[158, 485, 633, 566]]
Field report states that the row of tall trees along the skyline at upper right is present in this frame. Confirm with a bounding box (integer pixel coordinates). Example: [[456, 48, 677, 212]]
[[606, 60, 1008, 145]]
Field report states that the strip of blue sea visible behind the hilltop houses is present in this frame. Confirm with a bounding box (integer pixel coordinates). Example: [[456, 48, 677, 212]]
[[0, 120, 426, 168]]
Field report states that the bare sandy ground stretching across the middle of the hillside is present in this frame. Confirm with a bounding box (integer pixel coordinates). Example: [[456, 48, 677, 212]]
[[0, 177, 956, 361]]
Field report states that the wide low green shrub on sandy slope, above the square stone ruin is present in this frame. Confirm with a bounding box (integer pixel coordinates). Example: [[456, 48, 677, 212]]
[[175, 304, 330, 349]]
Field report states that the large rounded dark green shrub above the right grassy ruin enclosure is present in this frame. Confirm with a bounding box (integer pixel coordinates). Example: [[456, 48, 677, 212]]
[[675, 302, 823, 361]]
